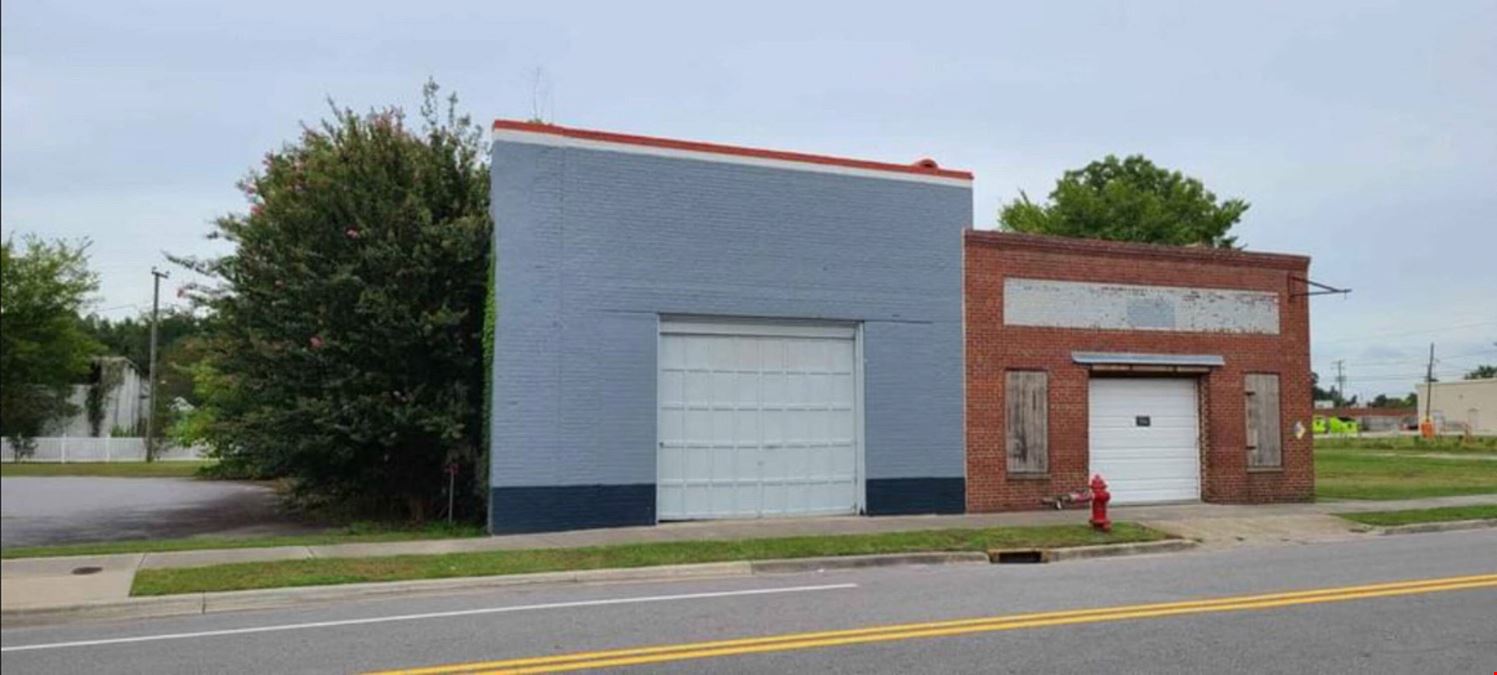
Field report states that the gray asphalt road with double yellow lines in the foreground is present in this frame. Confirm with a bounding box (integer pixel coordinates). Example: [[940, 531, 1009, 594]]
[[0, 530, 1497, 675]]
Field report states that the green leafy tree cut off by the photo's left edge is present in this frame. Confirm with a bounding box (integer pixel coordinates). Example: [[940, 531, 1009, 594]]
[[0, 236, 99, 456]]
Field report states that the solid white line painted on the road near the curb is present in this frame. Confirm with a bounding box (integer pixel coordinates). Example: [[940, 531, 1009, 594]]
[[0, 584, 858, 654]]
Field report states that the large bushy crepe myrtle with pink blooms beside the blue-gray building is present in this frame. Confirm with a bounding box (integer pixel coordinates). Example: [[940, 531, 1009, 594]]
[[177, 82, 491, 521]]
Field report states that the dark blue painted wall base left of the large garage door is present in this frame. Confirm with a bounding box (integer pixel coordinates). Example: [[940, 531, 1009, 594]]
[[488, 483, 656, 534]]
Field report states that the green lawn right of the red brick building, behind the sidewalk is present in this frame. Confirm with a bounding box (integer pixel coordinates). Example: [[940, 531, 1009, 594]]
[[1314, 439, 1497, 500]]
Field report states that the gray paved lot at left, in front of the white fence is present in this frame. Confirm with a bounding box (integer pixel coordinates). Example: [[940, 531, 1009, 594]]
[[0, 476, 305, 548]]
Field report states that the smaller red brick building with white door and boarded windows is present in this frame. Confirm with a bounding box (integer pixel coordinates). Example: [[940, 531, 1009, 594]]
[[964, 230, 1314, 512]]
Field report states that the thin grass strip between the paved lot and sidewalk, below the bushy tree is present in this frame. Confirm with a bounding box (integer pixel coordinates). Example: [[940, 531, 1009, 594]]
[[0, 522, 484, 558]]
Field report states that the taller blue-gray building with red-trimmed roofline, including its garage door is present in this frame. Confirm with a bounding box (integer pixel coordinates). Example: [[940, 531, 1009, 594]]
[[490, 121, 972, 533]]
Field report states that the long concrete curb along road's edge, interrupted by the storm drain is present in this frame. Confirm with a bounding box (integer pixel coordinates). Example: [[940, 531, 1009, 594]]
[[0, 539, 1196, 629]]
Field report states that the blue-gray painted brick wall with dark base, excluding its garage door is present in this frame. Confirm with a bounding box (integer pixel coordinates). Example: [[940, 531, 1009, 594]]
[[490, 141, 972, 533]]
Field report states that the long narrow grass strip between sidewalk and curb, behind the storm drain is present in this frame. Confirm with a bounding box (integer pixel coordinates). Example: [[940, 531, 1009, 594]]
[[130, 522, 1169, 596]]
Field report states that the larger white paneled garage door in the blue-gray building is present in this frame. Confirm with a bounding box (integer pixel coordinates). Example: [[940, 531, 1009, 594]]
[[656, 322, 859, 521]]
